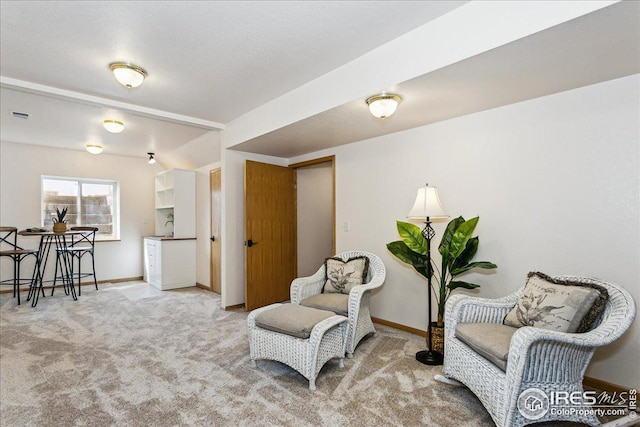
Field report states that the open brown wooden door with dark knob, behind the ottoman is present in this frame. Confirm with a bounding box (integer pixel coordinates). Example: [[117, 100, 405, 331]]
[[244, 160, 296, 311]]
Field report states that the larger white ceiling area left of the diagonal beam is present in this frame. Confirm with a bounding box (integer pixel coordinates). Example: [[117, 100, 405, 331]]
[[0, 0, 465, 156]]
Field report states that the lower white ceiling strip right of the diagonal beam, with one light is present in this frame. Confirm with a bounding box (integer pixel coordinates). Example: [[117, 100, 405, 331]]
[[233, 1, 640, 158]]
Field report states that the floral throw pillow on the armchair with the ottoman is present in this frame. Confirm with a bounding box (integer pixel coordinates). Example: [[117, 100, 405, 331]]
[[322, 256, 369, 294]]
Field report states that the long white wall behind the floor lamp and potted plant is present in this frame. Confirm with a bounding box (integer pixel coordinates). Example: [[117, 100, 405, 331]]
[[290, 75, 640, 387]]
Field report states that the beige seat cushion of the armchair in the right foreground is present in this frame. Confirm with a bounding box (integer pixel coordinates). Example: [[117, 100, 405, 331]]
[[456, 323, 518, 371]]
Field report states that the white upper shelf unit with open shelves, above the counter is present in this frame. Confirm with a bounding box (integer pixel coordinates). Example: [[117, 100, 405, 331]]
[[155, 169, 196, 238]]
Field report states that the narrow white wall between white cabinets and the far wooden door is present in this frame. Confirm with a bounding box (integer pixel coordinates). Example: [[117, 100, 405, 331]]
[[196, 163, 220, 286]]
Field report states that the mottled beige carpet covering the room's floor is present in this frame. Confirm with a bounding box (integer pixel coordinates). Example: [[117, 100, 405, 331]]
[[0, 283, 493, 427]]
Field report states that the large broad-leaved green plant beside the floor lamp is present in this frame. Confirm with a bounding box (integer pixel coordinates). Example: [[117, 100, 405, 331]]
[[387, 216, 498, 352]]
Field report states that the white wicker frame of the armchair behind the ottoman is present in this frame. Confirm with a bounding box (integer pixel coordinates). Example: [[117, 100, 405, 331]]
[[290, 251, 387, 358]]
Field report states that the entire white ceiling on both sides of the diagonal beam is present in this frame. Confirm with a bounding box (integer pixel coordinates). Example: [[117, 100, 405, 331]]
[[0, 0, 640, 164]]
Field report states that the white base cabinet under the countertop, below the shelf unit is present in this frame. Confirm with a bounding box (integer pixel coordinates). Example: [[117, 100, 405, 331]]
[[144, 237, 196, 291]]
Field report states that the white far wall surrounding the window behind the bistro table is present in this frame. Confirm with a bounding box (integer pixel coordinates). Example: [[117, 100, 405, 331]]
[[0, 141, 161, 280]]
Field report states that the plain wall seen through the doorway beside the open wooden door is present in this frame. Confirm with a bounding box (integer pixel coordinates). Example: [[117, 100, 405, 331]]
[[296, 162, 333, 277]]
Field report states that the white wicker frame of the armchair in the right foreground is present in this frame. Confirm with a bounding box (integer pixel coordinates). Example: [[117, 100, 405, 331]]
[[443, 276, 636, 427]]
